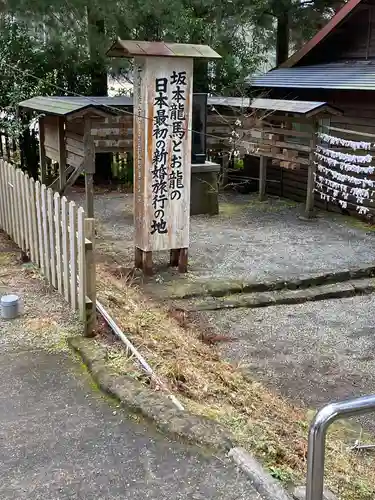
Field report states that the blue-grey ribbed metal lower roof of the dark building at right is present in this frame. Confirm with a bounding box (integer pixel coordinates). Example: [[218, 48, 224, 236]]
[[252, 61, 375, 90]]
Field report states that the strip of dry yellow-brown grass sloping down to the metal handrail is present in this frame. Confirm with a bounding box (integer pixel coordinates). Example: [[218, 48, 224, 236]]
[[98, 264, 375, 500]]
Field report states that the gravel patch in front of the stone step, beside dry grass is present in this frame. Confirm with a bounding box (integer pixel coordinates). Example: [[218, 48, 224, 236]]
[[200, 295, 375, 430]]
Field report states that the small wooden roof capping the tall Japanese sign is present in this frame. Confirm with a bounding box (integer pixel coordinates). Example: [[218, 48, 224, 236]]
[[107, 39, 221, 59]]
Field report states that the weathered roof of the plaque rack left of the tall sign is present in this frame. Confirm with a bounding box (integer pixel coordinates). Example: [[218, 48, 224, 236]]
[[19, 96, 129, 116]]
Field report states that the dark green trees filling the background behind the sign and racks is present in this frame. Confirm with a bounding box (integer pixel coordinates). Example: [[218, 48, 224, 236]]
[[0, 0, 343, 175]]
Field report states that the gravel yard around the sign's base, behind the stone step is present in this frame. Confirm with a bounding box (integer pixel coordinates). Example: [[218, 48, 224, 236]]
[[71, 192, 375, 288]]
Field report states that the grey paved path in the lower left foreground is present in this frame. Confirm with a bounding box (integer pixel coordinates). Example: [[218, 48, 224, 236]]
[[0, 349, 260, 500]]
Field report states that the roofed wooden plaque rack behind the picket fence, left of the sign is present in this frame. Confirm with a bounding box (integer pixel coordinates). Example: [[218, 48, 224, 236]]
[[19, 96, 133, 217]]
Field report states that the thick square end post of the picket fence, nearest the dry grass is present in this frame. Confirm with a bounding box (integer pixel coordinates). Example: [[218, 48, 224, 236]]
[[85, 218, 96, 337]]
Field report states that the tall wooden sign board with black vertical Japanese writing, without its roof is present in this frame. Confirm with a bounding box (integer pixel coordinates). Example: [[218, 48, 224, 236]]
[[133, 56, 193, 252]]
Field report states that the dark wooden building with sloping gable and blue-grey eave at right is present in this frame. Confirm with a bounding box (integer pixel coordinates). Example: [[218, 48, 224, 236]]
[[251, 0, 375, 219]]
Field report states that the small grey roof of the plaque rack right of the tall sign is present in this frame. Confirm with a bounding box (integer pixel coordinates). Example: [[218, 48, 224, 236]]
[[250, 99, 342, 118]]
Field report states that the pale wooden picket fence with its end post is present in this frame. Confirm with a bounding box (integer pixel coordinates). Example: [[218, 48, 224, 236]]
[[0, 160, 96, 334]]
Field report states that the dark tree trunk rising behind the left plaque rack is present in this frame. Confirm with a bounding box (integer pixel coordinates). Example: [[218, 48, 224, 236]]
[[87, 8, 113, 184]]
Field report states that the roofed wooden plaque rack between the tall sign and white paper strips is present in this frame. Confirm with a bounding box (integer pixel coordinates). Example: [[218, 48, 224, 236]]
[[218, 98, 341, 217]]
